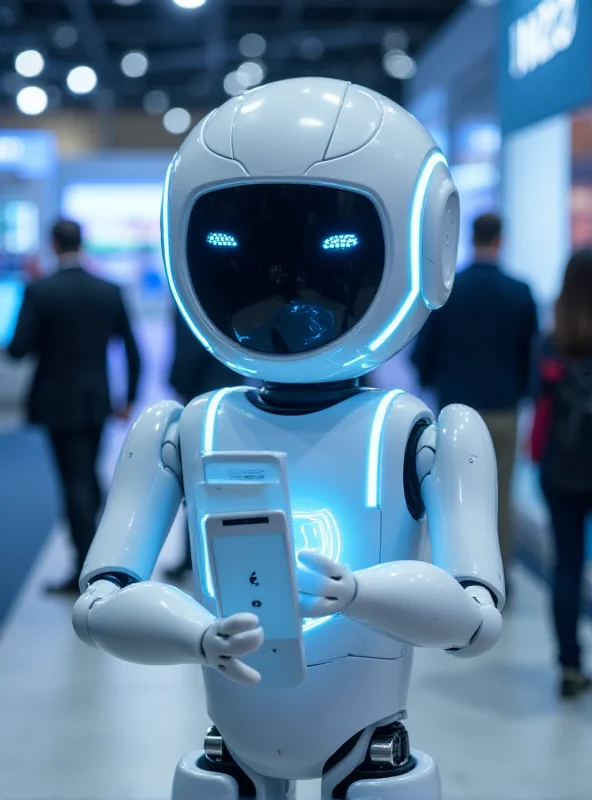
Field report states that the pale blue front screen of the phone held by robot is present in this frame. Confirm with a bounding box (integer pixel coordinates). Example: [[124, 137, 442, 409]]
[[212, 533, 300, 639]]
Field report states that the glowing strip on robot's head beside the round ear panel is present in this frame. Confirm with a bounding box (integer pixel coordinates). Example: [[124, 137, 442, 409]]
[[370, 151, 448, 352]]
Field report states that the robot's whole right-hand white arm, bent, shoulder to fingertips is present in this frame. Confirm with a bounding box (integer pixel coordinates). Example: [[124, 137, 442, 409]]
[[299, 406, 504, 657]]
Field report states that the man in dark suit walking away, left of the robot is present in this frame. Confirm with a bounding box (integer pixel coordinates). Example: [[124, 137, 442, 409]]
[[8, 220, 140, 592]]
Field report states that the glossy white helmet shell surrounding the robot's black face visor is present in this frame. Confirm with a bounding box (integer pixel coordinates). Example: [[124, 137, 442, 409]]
[[162, 78, 454, 383]]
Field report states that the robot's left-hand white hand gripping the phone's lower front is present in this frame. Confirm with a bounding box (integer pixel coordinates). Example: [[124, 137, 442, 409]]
[[202, 614, 263, 686]]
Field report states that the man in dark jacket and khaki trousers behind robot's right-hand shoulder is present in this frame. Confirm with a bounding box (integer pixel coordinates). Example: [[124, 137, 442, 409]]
[[411, 214, 538, 594]]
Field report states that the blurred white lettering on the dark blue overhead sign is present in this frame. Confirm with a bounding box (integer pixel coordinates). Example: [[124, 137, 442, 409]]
[[508, 0, 579, 79]]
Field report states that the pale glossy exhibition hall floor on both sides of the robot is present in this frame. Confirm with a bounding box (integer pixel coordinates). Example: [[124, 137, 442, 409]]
[[0, 532, 592, 800]]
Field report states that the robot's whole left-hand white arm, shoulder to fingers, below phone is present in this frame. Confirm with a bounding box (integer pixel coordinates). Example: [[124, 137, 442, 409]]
[[73, 402, 263, 684]]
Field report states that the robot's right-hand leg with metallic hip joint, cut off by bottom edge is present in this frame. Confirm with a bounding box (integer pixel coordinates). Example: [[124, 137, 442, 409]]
[[322, 721, 442, 800]]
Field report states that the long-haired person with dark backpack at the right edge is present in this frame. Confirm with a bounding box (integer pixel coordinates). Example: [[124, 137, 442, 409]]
[[532, 250, 592, 698]]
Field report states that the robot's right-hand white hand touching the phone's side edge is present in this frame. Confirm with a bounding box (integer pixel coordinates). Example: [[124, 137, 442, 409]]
[[298, 550, 356, 617]]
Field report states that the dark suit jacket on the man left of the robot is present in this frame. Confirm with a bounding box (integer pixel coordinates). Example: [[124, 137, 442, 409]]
[[8, 267, 140, 428]]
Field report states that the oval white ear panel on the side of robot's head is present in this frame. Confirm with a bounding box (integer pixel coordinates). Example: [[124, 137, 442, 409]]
[[421, 164, 460, 310]]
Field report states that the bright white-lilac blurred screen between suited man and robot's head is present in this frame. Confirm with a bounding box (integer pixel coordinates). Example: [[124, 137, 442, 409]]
[[62, 183, 166, 290]]
